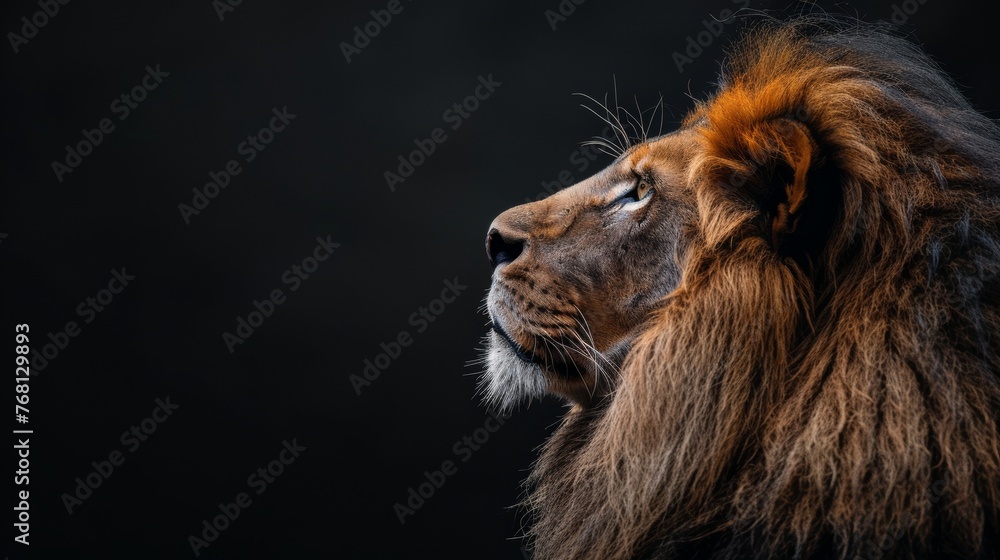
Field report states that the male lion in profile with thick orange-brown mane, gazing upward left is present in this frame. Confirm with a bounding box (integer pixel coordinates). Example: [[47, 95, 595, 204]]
[[482, 16, 1000, 560]]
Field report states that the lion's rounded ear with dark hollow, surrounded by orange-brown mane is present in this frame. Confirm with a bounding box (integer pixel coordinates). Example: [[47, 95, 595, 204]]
[[761, 118, 818, 247]]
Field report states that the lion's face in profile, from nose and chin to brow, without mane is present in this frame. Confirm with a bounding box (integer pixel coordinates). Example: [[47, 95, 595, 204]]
[[484, 130, 698, 406]]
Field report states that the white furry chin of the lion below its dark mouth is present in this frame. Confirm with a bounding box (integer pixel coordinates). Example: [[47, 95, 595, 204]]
[[481, 332, 548, 410]]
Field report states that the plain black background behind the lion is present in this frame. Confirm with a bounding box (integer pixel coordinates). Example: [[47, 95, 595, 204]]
[[0, 0, 1000, 558]]
